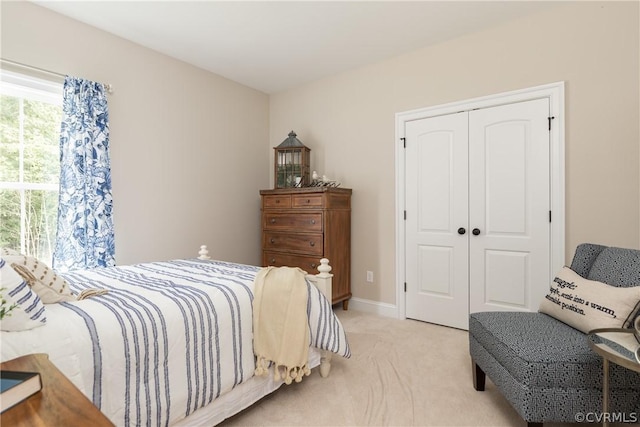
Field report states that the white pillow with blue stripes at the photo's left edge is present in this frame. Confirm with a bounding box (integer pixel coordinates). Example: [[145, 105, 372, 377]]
[[0, 257, 47, 331]]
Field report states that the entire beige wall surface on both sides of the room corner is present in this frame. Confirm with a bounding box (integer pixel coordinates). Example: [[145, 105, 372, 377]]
[[0, 2, 640, 310]]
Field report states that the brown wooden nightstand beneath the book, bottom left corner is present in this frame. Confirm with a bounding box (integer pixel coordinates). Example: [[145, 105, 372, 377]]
[[0, 354, 113, 427]]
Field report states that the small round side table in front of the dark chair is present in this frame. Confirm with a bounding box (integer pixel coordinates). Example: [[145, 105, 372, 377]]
[[587, 328, 640, 426]]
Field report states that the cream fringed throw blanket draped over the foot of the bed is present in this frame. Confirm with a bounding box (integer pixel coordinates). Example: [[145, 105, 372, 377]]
[[253, 267, 311, 384]]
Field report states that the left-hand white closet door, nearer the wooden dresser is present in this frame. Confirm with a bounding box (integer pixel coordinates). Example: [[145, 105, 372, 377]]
[[405, 112, 469, 329]]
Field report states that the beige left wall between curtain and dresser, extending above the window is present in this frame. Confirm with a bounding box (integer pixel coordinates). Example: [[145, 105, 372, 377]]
[[1, 2, 270, 264]]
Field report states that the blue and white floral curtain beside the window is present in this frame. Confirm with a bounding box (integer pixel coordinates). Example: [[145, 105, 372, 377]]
[[53, 77, 115, 271]]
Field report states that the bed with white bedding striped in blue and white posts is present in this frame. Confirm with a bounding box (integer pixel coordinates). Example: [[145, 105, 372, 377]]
[[0, 251, 350, 426]]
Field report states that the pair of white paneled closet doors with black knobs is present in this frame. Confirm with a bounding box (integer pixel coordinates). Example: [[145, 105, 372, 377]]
[[405, 98, 551, 329]]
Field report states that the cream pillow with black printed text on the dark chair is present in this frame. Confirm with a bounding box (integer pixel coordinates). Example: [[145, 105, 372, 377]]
[[538, 267, 640, 333]]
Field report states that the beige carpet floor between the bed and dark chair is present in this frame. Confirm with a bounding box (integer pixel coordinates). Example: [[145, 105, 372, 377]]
[[221, 310, 629, 427]]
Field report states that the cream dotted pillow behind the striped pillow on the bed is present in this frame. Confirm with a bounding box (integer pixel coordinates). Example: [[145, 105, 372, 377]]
[[4, 254, 77, 304]]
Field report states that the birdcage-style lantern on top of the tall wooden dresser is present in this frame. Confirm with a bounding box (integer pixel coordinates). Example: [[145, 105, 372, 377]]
[[273, 131, 311, 188]]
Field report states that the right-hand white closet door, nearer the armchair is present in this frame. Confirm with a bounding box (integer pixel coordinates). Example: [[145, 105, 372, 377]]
[[469, 98, 551, 313]]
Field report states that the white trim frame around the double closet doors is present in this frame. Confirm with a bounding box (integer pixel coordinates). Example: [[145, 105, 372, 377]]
[[395, 82, 565, 319]]
